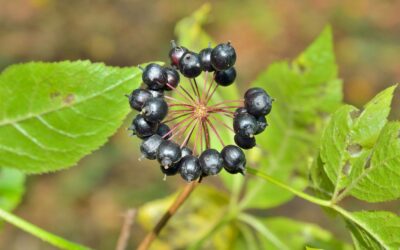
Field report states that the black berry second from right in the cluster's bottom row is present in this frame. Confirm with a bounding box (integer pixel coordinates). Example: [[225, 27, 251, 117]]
[[199, 149, 223, 175]]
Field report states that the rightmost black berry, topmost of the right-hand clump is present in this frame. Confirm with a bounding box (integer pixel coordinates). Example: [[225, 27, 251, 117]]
[[244, 90, 272, 116]]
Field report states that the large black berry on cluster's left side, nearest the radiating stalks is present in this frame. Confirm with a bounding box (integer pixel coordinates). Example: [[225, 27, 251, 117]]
[[141, 98, 168, 122]]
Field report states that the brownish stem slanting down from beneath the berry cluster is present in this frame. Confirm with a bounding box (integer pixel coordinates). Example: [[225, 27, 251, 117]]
[[137, 181, 198, 250]]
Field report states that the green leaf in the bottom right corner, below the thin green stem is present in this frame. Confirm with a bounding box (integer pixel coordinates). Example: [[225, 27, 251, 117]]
[[347, 211, 400, 250]]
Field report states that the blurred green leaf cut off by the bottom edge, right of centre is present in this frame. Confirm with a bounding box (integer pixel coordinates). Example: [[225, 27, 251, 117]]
[[241, 217, 351, 250]]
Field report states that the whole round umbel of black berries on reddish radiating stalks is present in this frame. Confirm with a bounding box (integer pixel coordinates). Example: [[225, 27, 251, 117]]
[[128, 41, 273, 182]]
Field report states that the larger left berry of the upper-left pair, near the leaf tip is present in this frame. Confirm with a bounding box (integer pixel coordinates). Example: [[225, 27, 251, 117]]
[[142, 63, 168, 90]]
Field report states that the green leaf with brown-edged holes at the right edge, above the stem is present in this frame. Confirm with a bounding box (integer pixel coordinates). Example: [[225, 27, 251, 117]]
[[320, 86, 400, 202]]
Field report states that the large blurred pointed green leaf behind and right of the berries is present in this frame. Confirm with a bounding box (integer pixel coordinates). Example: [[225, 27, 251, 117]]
[[244, 25, 342, 208]]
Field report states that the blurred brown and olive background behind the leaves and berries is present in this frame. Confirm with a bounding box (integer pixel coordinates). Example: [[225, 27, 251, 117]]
[[0, 0, 400, 250]]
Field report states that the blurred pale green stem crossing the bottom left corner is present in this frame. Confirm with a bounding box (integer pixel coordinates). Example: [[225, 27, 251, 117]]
[[0, 208, 90, 250]]
